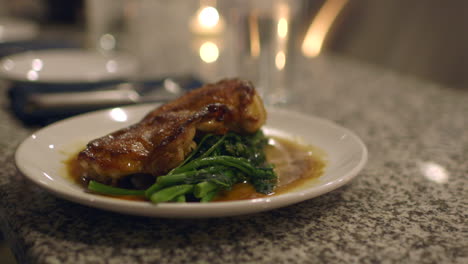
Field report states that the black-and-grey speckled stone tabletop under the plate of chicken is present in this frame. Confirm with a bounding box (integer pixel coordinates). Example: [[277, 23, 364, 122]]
[[0, 56, 468, 263]]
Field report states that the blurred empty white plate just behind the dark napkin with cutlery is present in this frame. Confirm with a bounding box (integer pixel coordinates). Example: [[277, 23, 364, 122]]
[[0, 49, 137, 84]]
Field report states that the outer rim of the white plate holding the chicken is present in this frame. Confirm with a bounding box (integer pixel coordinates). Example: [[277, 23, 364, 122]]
[[14, 104, 368, 218]]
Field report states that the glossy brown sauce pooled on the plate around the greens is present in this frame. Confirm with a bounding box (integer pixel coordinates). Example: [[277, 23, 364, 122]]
[[66, 137, 326, 201]]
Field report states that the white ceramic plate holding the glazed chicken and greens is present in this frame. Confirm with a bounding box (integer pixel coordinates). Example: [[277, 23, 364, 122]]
[[15, 105, 367, 218]]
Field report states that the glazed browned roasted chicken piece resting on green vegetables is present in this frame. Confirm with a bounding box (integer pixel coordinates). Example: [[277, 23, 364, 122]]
[[77, 79, 266, 185]]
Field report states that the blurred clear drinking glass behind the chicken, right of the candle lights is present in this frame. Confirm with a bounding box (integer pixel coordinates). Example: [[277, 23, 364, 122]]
[[222, 0, 302, 104]]
